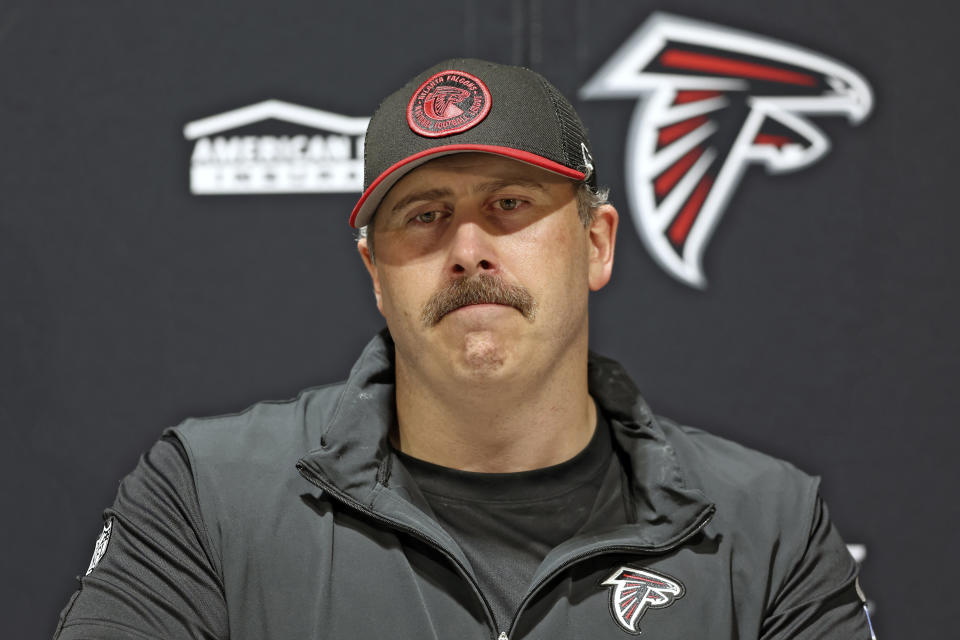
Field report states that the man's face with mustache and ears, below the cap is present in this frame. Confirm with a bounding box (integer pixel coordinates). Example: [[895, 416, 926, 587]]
[[359, 153, 616, 382]]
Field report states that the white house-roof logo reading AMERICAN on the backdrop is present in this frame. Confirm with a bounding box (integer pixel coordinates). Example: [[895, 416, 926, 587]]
[[183, 100, 370, 195]]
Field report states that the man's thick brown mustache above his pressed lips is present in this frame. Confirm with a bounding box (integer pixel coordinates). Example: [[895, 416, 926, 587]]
[[420, 274, 537, 327]]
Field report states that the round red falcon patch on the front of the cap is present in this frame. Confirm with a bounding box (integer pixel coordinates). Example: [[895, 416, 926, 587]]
[[407, 69, 490, 138]]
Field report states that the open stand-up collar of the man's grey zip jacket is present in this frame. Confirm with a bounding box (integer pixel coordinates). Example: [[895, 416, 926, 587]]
[[300, 329, 713, 549]]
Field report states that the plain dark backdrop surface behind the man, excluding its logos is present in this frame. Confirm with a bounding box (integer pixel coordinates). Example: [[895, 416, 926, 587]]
[[0, 0, 960, 638]]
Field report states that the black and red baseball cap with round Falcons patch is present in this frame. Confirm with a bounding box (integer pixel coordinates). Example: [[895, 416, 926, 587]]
[[350, 58, 596, 227]]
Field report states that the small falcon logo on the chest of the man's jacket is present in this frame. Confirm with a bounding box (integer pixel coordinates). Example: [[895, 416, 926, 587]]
[[600, 567, 684, 634]]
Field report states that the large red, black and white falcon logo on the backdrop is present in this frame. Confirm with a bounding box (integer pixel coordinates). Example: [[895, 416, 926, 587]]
[[580, 13, 873, 288]]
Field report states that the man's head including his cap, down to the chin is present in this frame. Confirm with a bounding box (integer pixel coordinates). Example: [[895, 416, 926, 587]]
[[351, 60, 617, 380]]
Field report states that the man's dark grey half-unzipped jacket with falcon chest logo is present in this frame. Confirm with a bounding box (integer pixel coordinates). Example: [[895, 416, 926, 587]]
[[59, 332, 871, 640]]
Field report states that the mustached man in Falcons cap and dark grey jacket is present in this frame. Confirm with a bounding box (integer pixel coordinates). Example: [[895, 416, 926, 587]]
[[58, 59, 871, 640]]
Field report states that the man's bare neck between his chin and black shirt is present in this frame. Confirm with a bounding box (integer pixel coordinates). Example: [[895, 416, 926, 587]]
[[393, 350, 597, 473]]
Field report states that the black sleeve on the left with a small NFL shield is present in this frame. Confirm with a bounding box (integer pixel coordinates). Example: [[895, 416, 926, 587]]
[[54, 436, 229, 640]]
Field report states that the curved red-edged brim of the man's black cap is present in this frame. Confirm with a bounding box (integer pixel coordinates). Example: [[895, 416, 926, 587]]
[[350, 144, 586, 228]]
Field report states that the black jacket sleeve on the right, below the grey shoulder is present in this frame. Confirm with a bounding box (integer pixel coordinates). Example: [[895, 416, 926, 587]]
[[760, 495, 875, 640]]
